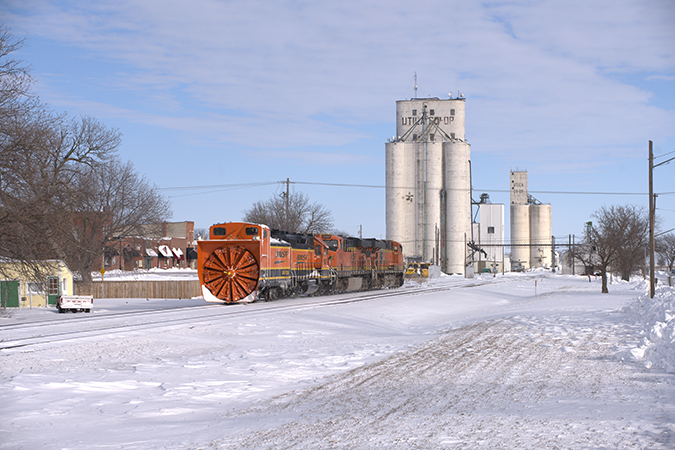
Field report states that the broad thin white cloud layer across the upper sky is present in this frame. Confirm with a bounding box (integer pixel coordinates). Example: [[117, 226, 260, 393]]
[[5, 0, 675, 157]]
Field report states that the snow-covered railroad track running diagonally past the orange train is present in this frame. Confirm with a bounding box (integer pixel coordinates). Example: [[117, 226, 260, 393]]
[[0, 279, 528, 354]]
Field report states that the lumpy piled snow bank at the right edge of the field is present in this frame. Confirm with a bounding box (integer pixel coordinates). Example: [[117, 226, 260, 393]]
[[622, 281, 675, 373]]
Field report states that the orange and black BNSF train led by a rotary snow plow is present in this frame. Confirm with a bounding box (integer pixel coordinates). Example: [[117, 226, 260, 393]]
[[198, 222, 405, 303]]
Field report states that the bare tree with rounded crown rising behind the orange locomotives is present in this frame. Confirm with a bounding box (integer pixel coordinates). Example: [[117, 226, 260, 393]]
[[244, 192, 333, 234]]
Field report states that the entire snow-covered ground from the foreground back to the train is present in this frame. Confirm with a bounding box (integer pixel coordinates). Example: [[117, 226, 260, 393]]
[[0, 272, 675, 449]]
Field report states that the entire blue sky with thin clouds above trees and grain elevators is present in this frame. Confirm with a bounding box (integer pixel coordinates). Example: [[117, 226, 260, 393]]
[[0, 0, 675, 241]]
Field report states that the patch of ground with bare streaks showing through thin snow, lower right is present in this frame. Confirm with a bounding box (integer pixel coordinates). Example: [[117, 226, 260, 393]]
[[211, 316, 675, 449]]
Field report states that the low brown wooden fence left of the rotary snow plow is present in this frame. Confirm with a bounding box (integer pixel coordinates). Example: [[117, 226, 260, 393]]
[[74, 280, 202, 298]]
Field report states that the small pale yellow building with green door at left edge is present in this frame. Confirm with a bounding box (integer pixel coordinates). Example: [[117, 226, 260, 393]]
[[0, 260, 73, 308]]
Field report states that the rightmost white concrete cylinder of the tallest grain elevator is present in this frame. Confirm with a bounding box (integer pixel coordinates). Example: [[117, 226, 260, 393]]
[[443, 140, 471, 275]]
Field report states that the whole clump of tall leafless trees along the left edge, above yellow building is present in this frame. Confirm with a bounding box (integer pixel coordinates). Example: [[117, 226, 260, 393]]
[[0, 27, 170, 280]]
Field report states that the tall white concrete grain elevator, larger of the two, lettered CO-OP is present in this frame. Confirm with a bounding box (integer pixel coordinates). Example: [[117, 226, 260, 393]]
[[385, 96, 472, 274]]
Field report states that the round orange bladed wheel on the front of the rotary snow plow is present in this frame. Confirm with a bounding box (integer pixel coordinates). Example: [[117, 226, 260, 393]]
[[204, 246, 260, 303]]
